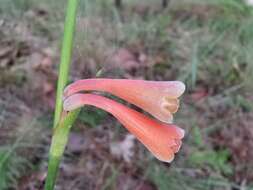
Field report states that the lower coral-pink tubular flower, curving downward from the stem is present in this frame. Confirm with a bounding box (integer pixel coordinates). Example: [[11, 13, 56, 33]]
[[63, 94, 184, 162]]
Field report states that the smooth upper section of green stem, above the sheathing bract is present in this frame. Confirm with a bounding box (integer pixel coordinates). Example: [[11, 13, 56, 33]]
[[54, 0, 78, 127]]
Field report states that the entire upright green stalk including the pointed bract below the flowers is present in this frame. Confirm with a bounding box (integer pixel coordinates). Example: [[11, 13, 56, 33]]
[[44, 0, 79, 190]]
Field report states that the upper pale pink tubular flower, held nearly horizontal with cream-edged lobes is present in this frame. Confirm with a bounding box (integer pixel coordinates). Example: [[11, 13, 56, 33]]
[[64, 79, 185, 123]]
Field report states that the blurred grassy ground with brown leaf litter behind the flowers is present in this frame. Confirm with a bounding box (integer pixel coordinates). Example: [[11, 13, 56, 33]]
[[0, 0, 253, 190]]
